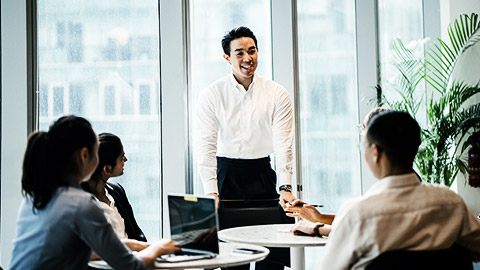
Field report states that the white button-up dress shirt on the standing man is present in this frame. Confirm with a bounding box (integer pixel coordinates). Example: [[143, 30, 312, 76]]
[[194, 74, 294, 194]]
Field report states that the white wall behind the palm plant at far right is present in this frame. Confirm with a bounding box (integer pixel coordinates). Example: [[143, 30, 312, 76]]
[[440, 0, 480, 213]]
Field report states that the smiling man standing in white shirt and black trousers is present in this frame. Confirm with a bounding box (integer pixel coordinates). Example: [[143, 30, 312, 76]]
[[194, 27, 296, 269]]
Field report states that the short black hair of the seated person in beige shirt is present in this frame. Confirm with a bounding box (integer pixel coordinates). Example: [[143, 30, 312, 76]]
[[366, 111, 421, 169]]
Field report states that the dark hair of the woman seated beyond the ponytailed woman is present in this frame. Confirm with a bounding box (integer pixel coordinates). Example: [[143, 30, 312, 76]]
[[90, 133, 123, 182]]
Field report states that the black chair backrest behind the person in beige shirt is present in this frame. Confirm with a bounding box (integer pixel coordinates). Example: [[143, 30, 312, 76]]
[[365, 244, 473, 270]]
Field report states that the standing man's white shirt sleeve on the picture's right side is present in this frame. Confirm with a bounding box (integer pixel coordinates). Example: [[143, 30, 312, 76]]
[[272, 86, 294, 186]]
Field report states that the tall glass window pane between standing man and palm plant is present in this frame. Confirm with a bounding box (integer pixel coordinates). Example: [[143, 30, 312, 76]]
[[297, 0, 361, 217]]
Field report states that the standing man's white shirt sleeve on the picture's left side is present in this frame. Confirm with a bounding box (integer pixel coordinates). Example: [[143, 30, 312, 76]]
[[194, 90, 218, 194]]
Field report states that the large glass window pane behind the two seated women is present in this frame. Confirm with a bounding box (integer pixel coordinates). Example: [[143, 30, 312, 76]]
[[37, 0, 161, 240]]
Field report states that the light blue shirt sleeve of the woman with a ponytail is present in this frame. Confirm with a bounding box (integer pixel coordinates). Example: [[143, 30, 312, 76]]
[[75, 198, 146, 270]]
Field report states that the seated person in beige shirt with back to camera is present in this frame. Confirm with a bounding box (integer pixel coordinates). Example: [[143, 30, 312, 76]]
[[288, 111, 480, 270]]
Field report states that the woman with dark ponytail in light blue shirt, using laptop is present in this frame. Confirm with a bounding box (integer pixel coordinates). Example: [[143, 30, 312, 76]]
[[10, 116, 180, 270]]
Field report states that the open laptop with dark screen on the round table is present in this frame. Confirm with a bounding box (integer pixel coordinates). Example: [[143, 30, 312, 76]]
[[157, 194, 219, 262]]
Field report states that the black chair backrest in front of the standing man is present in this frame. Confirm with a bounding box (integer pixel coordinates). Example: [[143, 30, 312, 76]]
[[218, 201, 295, 230]]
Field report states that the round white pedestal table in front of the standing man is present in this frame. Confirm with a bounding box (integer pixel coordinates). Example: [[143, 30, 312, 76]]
[[218, 224, 327, 270]]
